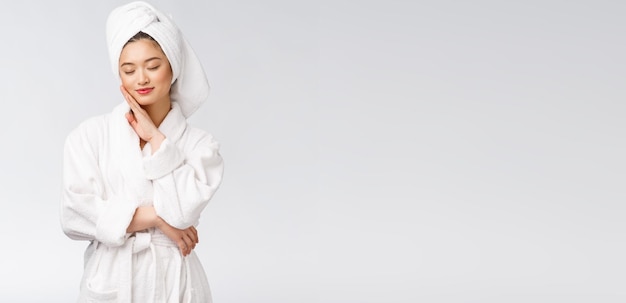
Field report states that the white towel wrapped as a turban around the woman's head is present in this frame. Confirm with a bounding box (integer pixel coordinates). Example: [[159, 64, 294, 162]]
[[106, 1, 210, 117]]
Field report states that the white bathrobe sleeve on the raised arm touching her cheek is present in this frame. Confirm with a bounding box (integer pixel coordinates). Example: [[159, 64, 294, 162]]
[[144, 130, 223, 229]]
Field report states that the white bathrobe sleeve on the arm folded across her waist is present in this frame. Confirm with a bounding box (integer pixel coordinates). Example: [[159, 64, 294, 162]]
[[61, 120, 137, 247]]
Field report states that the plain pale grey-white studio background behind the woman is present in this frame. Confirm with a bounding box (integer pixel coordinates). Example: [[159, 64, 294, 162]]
[[0, 0, 626, 303]]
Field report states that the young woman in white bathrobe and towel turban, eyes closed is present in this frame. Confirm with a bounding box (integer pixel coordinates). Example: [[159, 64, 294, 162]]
[[61, 2, 223, 303]]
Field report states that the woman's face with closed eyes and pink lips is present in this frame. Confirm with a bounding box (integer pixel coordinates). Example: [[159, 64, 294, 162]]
[[119, 39, 172, 106]]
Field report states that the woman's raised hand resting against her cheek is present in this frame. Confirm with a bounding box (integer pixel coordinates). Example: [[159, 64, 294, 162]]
[[120, 85, 165, 150]]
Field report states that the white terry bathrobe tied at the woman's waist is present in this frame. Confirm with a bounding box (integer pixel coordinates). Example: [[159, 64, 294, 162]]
[[61, 103, 223, 303]]
